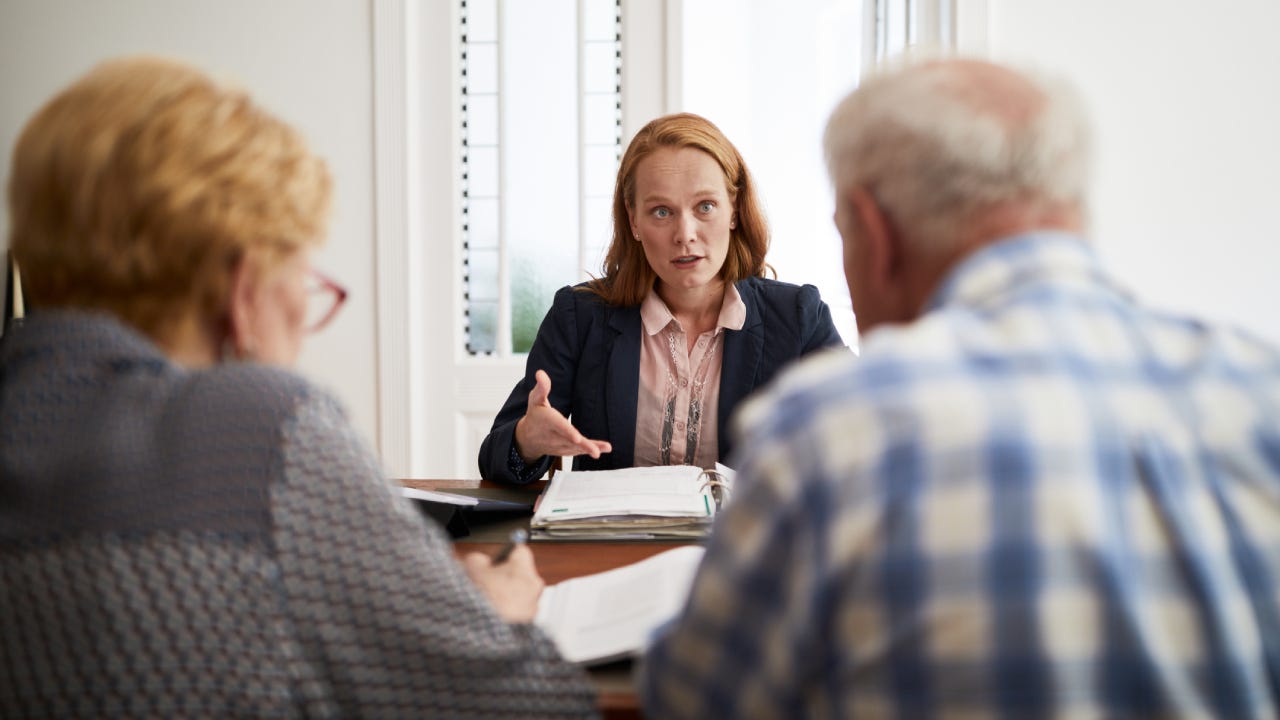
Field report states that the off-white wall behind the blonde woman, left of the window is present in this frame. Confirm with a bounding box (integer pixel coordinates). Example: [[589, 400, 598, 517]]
[[0, 0, 378, 441]]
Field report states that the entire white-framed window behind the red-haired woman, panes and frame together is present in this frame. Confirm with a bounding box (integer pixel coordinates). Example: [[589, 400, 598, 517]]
[[372, 0, 957, 478]]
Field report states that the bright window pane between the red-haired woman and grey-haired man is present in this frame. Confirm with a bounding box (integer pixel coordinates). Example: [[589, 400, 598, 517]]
[[675, 0, 951, 346]]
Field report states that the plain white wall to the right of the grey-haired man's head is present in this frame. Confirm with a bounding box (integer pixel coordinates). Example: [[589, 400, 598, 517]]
[[987, 0, 1280, 342]]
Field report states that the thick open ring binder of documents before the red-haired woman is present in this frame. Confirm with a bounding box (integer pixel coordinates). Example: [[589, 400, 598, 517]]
[[530, 465, 732, 539]]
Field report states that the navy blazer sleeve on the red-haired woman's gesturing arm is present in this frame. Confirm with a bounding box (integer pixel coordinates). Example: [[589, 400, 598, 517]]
[[479, 287, 580, 484]]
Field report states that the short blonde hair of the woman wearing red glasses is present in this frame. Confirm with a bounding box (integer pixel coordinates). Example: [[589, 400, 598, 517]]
[[9, 58, 332, 341]]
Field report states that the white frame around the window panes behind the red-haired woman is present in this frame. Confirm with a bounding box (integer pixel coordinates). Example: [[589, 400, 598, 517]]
[[371, 0, 987, 478]]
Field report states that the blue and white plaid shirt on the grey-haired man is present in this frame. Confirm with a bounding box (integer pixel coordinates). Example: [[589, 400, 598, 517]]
[[641, 233, 1280, 717]]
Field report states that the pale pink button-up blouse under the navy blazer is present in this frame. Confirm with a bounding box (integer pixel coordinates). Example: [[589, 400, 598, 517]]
[[635, 284, 746, 468]]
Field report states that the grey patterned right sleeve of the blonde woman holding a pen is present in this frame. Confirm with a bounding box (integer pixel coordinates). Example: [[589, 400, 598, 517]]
[[271, 389, 595, 717]]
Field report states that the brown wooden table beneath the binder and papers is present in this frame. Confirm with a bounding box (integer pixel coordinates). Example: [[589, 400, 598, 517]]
[[401, 479, 687, 719]]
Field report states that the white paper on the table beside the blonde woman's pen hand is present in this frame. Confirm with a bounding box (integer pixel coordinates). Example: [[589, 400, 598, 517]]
[[535, 544, 704, 665]]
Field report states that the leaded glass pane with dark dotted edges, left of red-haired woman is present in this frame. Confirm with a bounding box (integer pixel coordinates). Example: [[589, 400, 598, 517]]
[[460, 0, 622, 356]]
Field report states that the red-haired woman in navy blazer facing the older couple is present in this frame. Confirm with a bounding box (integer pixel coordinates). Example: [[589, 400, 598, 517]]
[[480, 114, 842, 483]]
